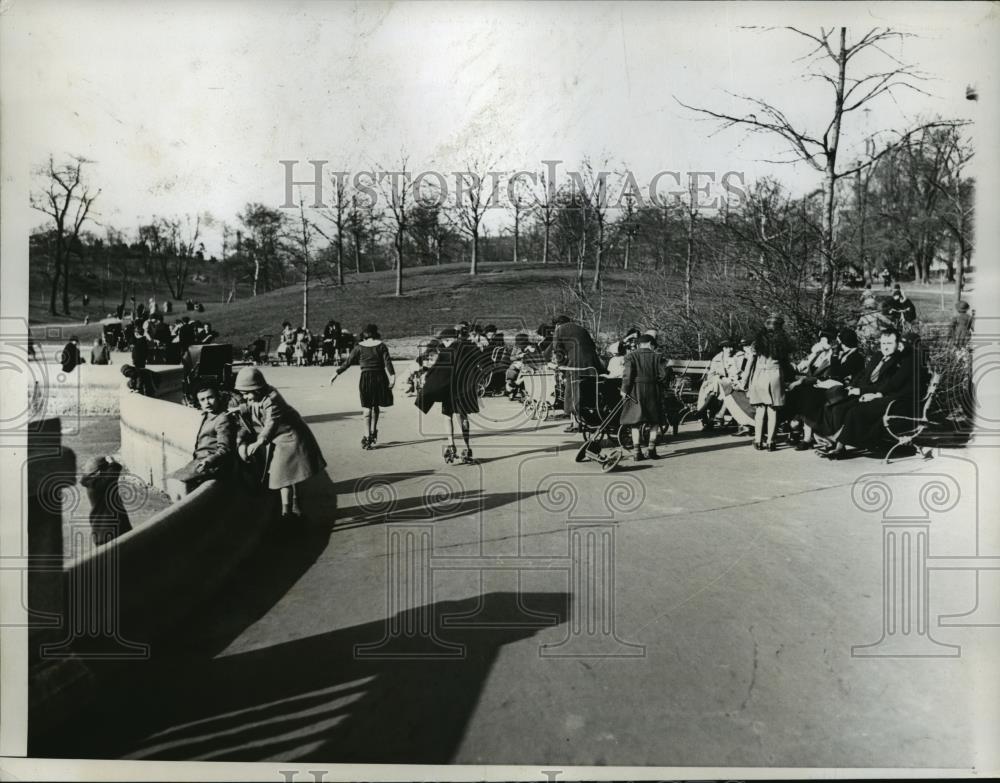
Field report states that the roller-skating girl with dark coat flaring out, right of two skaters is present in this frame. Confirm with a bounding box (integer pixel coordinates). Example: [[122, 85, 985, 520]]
[[414, 327, 483, 464]]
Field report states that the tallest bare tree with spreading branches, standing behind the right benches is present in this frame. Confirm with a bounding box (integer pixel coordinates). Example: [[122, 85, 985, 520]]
[[678, 27, 948, 312]]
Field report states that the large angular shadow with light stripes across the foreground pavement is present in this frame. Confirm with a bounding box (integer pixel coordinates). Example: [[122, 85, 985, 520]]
[[39, 593, 569, 764]]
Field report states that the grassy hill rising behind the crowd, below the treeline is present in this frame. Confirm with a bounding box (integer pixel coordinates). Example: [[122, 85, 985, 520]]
[[31, 263, 954, 356]]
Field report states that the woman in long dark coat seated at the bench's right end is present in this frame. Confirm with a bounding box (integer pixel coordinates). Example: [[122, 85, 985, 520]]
[[816, 329, 921, 459]]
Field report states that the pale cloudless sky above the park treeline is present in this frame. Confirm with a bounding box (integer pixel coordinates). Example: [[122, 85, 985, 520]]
[[0, 0, 997, 252]]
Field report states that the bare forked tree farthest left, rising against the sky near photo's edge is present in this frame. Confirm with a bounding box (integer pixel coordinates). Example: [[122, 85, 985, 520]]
[[31, 155, 101, 315]]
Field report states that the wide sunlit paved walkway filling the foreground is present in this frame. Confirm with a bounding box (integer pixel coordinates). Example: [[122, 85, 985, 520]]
[[35, 368, 998, 768]]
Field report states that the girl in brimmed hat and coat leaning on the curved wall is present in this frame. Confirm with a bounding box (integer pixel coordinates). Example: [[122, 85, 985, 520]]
[[234, 367, 326, 518]]
